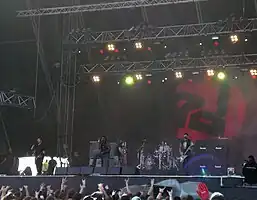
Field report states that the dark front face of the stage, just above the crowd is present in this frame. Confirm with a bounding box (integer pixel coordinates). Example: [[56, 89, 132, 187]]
[[0, 175, 257, 200]]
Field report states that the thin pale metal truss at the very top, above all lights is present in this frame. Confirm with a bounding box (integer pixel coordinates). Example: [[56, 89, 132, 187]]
[[17, 0, 207, 17]]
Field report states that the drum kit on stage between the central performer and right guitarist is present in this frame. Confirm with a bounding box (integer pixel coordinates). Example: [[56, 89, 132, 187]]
[[139, 142, 179, 170]]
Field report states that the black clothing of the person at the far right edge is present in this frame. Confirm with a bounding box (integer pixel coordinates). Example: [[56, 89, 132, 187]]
[[243, 162, 257, 184]]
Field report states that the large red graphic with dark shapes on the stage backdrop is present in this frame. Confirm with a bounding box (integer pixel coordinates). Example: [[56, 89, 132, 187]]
[[177, 81, 246, 140]]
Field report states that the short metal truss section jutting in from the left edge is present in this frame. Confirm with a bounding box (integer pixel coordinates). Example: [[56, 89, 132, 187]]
[[0, 91, 36, 109]]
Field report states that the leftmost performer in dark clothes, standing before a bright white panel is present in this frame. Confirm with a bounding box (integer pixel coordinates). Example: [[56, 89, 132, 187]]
[[31, 138, 45, 175]]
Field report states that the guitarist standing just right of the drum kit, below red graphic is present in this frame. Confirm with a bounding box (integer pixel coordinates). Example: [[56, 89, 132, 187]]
[[179, 133, 194, 168]]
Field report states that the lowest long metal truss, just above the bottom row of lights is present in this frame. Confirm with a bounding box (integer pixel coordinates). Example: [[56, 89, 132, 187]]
[[82, 54, 257, 73]]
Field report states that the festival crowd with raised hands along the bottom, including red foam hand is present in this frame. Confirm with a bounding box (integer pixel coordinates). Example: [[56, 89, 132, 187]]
[[0, 178, 225, 200]]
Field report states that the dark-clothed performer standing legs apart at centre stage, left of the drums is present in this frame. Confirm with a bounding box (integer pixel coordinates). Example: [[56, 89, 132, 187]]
[[92, 136, 111, 167]]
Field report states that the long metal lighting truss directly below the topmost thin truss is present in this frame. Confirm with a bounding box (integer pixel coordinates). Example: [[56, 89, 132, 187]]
[[65, 18, 257, 45]]
